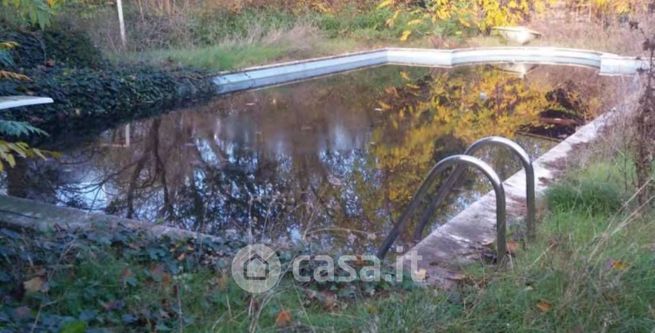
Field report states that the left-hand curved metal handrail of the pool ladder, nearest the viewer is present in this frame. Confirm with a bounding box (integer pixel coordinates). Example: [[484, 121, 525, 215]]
[[377, 155, 507, 262]]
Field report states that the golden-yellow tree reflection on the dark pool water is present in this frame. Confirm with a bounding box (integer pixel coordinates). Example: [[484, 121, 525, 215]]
[[369, 69, 552, 211]]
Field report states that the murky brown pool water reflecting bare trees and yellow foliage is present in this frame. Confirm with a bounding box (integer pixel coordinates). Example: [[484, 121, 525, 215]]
[[2, 66, 624, 250]]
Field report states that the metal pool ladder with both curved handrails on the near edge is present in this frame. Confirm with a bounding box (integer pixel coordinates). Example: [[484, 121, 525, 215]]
[[377, 136, 536, 262]]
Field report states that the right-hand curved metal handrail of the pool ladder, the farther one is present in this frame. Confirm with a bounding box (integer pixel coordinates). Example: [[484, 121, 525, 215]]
[[413, 136, 536, 241]]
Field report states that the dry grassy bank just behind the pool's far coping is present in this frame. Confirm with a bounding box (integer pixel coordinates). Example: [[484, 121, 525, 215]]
[[106, 8, 436, 71]]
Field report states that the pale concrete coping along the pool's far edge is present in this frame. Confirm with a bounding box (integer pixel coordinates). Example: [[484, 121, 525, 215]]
[[212, 47, 648, 94]]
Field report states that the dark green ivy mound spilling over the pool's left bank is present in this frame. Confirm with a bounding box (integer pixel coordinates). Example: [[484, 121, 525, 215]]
[[0, 27, 215, 136]]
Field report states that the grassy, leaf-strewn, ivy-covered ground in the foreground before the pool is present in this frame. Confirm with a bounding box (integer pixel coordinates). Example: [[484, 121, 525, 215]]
[[0, 156, 655, 332]]
